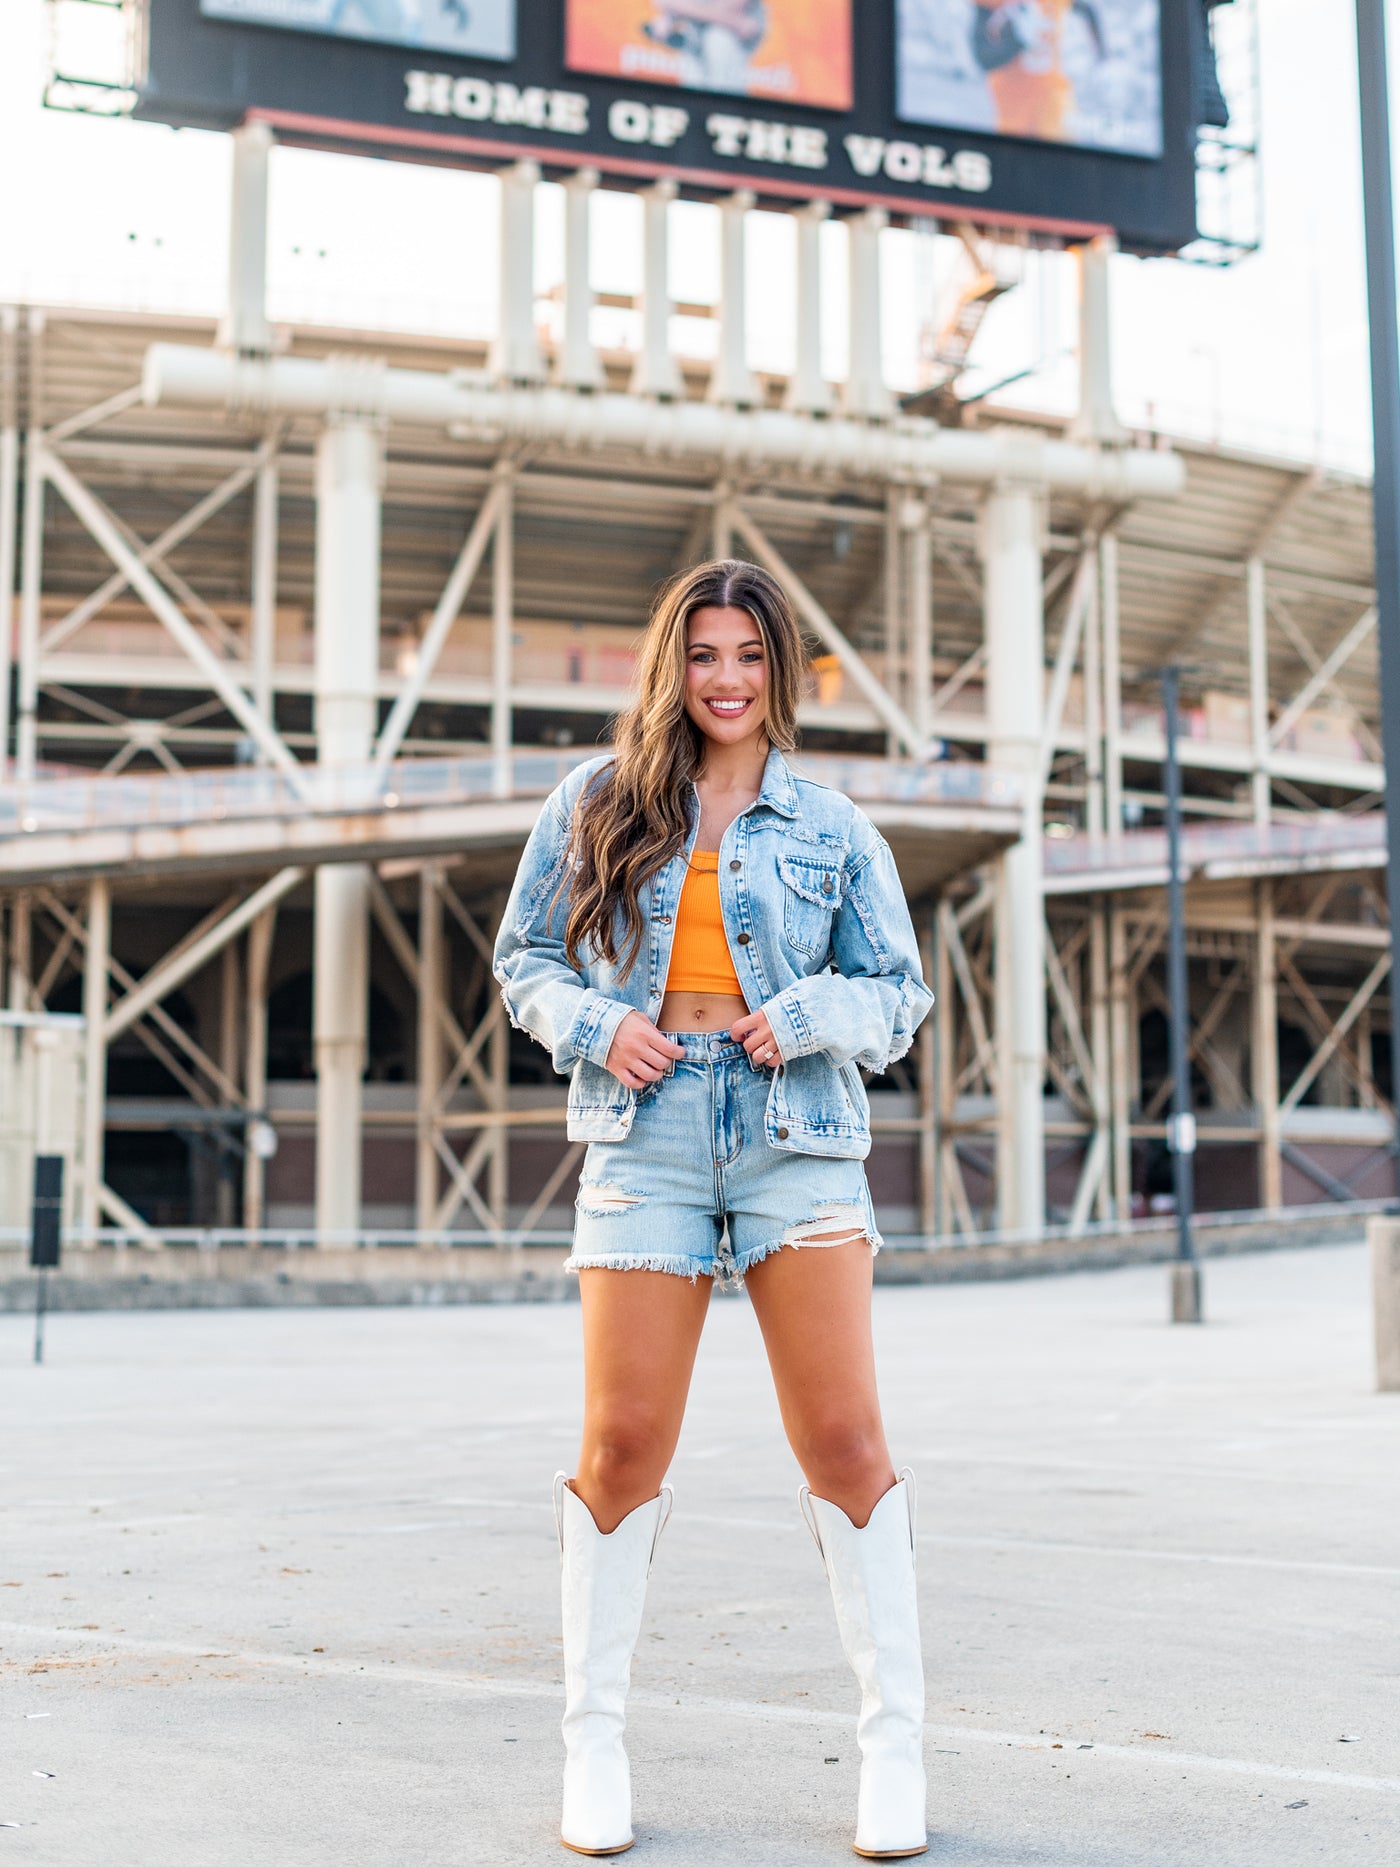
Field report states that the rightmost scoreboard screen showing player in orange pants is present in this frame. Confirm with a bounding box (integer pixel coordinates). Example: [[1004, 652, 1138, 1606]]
[[896, 0, 1163, 157]]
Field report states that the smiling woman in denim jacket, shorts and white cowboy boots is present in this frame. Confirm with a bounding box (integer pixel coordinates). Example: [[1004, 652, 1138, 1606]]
[[495, 562, 931, 1860]]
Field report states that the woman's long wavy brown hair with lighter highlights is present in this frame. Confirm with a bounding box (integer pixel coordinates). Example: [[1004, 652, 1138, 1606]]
[[560, 558, 806, 978]]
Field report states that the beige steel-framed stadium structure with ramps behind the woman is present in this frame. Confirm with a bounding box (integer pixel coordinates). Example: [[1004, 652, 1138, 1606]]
[[0, 0, 1394, 1249]]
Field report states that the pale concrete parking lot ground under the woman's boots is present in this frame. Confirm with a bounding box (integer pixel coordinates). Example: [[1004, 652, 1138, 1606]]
[[0, 1247, 1400, 1867]]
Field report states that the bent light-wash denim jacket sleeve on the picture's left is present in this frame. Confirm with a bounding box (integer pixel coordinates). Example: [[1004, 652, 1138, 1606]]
[[491, 779, 629, 1074]]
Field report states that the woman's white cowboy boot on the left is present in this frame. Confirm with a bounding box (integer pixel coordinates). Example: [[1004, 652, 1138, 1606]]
[[554, 1471, 672, 1854]]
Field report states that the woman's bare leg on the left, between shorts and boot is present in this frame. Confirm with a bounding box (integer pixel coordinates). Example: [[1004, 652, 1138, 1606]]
[[573, 1270, 711, 1537]]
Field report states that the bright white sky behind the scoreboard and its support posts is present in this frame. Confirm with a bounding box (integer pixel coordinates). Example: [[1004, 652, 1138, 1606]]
[[0, 0, 1370, 472]]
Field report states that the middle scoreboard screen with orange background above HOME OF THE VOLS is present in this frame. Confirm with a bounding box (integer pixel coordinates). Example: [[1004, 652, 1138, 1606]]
[[564, 0, 853, 110]]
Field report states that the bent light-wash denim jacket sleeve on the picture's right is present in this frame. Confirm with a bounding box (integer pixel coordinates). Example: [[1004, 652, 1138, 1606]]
[[763, 827, 933, 1072]]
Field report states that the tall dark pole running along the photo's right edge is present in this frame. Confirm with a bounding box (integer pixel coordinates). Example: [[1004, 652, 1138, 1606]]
[[1357, 0, 1400, 1135]]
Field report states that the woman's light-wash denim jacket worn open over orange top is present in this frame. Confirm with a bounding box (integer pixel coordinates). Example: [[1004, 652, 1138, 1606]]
[[495, 751, 933, 1159]]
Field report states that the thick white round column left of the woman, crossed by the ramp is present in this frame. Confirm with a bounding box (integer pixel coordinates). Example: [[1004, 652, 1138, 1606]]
[[314, 416, 381, 1234]]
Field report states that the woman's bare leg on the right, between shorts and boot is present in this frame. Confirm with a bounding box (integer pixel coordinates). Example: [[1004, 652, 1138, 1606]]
[[745, 1232, 894, 1529]]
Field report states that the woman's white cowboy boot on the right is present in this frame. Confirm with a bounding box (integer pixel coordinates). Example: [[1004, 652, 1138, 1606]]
[[799, 1467, 928, 1860]]
